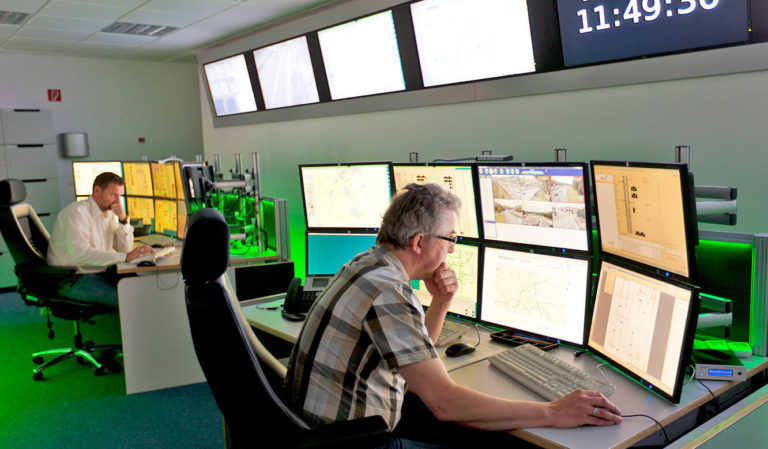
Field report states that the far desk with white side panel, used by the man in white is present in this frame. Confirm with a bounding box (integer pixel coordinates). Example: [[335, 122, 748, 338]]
[[117, 245, 277, 394]]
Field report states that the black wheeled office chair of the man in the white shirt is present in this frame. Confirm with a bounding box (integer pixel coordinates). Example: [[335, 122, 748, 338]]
[[0, 179, 120, 380]]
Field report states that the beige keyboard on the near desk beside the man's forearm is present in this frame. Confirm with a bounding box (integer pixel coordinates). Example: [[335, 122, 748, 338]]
[[488, 344, 616, 401]]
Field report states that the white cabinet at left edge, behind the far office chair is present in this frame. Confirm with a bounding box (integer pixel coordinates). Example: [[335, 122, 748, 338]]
[[0, 109, 60, 288]]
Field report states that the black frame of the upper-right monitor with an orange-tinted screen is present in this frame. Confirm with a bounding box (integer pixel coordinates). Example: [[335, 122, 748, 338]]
[[589, 160, 698, 284]]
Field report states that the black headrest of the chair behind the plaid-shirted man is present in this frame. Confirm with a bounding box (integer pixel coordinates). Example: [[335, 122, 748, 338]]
[[181, 208, 229, 284]]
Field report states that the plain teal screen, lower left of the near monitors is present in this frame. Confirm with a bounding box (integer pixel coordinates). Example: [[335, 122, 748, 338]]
[[306, 232, 376, 276]]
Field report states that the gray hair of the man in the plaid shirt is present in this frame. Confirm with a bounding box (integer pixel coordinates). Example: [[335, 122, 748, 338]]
[[376, 184, 461, 249]]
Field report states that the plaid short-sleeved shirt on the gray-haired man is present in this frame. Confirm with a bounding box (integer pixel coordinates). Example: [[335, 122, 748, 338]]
[[286, 245, 438, 429]]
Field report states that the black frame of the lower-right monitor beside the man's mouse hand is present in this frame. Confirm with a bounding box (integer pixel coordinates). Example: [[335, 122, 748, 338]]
[[586, 259, 700, 404]]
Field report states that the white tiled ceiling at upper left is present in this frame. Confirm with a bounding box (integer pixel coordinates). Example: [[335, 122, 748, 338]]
[[0, 0, 331, 62]]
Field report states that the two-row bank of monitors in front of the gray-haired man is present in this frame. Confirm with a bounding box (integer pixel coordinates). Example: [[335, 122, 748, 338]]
[[299, 161, 698, 401]]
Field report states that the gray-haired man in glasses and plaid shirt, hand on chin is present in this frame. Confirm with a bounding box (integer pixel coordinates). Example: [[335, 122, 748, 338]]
[[286, 184, 621, 447]]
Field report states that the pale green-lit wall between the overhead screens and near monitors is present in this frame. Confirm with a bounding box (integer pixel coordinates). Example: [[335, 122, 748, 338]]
[[201, 67, 768, 262]]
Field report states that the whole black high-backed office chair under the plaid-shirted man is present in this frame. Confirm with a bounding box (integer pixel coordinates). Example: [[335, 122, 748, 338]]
[[181, 209, 387, 448]]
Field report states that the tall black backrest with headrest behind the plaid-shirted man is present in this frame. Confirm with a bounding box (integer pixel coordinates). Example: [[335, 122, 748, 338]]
[[181, 209, 308, 442]]
